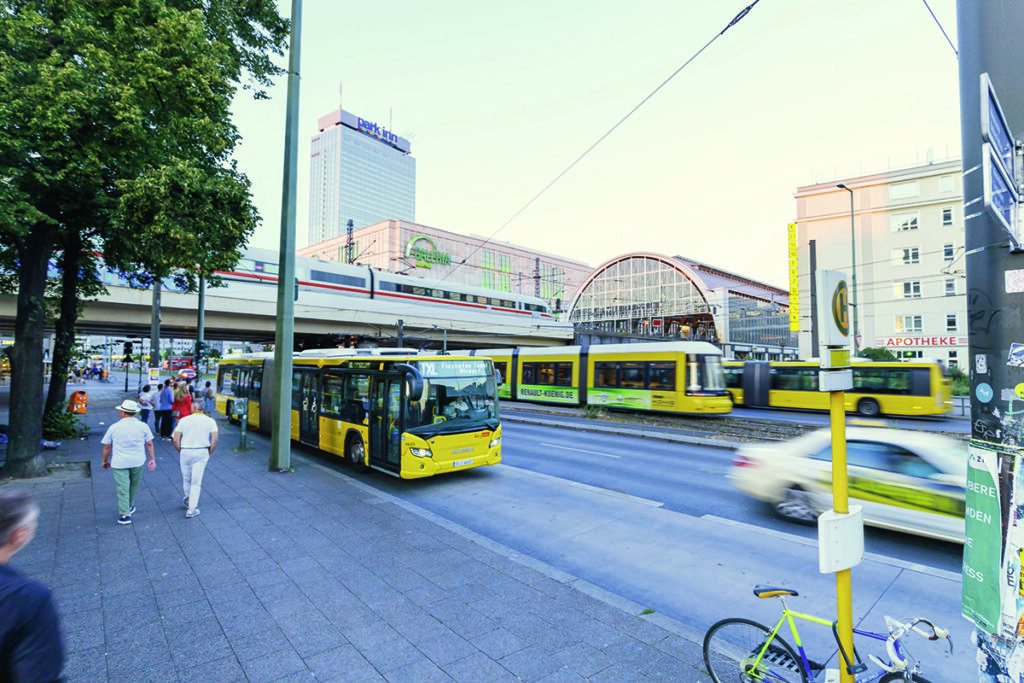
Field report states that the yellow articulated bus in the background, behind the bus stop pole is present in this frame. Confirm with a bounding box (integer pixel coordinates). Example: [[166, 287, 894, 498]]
[[722, 360, 953, 417]]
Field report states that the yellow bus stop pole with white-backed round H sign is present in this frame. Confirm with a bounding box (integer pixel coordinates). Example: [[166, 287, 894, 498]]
[[817, 270, 864, 683]]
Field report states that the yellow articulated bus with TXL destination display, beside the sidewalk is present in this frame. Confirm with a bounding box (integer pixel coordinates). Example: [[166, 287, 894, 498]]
[[216, 349, 502, 479]]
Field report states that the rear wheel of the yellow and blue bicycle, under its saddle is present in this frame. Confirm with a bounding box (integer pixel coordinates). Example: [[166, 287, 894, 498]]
[[703, 618, 807, 683]]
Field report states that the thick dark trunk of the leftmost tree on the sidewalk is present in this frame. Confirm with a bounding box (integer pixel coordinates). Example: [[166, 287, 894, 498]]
[[0, 224, 56, 479]]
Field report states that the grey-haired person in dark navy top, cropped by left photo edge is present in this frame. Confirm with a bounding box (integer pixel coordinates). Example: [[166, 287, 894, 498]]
[[0, 486, 63, 681]]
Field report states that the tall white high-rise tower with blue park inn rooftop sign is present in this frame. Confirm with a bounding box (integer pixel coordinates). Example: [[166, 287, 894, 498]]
[[308, 108, 416, 245]]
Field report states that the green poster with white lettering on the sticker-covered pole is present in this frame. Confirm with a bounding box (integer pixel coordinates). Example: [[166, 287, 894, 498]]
[[963, 444, 1002, 634]]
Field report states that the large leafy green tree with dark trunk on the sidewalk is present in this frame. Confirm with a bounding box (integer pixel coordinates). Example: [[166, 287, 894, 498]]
[[0, 0, 288, 477]]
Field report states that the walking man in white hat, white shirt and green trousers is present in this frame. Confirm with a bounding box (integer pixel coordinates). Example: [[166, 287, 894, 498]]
[[101, 400, 157, 524]]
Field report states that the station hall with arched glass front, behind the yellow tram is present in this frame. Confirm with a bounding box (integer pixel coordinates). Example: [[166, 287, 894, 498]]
[[567, 252, 797, 360]]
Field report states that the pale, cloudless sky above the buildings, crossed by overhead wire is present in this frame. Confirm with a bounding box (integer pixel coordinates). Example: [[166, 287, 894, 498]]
[[232, 0, 961, 288]]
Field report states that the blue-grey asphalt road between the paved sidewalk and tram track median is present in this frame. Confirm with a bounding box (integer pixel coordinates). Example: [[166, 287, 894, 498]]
[[348, 423, 976, 683]]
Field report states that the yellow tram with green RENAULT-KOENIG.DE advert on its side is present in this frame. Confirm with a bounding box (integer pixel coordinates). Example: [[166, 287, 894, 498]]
[[468, 342, 732, 414]]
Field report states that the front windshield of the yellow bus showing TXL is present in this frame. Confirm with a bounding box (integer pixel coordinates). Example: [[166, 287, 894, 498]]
[[406, 359, 500, 438]]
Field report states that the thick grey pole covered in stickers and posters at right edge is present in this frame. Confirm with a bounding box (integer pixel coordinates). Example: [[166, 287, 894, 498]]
[[950, 0, 1024, 681]]
